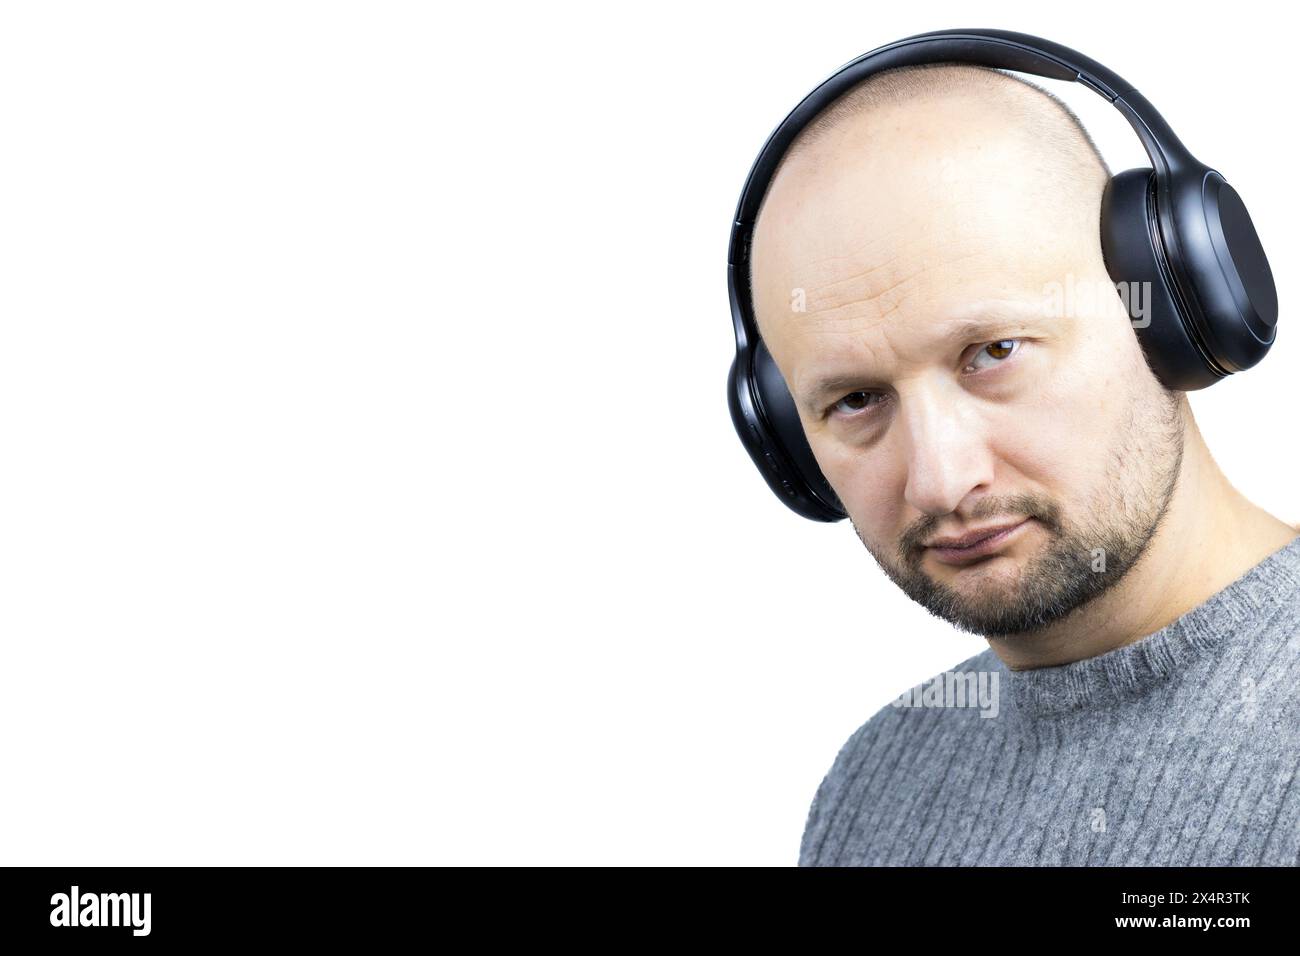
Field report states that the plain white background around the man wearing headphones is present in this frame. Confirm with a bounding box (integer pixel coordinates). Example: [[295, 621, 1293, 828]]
[[0, 0, 1300, 865]]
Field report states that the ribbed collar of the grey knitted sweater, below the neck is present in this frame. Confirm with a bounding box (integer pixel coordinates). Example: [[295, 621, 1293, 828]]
[[985, 537, 1300, 717]]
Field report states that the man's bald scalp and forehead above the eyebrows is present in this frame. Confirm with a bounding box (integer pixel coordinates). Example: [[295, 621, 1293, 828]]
[[750, 64, 1110, 398]]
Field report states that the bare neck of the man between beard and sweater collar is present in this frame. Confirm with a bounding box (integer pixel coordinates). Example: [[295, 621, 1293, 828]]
[[989, 408, 1300, 670]]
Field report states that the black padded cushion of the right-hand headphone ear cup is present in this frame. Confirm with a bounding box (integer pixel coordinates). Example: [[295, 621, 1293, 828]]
[[1101, 166, 1223, 392]]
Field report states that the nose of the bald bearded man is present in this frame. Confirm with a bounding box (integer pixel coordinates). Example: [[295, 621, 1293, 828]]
[[898, 384, 993, 516]]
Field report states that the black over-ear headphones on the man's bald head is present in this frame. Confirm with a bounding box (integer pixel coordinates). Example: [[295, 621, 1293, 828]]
[[727, 30, 1278, 522]]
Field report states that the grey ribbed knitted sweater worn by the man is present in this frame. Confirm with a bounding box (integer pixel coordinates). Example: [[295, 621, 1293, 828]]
[[798, 537, 1300, 866]]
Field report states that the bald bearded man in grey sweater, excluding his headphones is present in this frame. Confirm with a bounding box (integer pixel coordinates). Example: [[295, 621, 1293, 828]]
[[751, 64, 1300, 865]]
